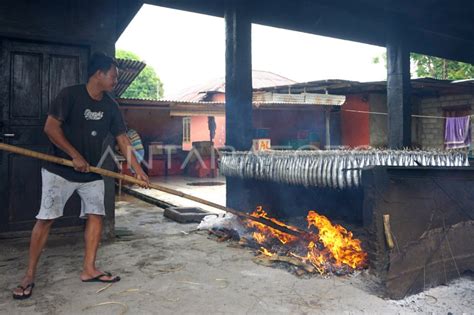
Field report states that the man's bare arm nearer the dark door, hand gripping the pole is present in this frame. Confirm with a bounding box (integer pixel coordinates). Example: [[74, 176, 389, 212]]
[[44, 116, 89, 173]]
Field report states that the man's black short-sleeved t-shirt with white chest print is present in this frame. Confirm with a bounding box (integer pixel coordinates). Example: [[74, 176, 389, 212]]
[[44, 85, 126, 182]]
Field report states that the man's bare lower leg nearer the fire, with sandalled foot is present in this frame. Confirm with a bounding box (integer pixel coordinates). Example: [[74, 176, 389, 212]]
[[81, 214, 114, 280]]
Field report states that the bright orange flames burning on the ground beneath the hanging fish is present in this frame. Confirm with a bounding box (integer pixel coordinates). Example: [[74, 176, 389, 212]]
[[245, 207, 367, 274]]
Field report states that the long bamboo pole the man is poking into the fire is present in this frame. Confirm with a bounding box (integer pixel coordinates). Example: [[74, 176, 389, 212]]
[[0, 143, 308, 237]]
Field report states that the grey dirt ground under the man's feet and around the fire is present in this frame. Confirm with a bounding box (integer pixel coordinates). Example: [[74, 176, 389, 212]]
[[0, 197, 474, 314]]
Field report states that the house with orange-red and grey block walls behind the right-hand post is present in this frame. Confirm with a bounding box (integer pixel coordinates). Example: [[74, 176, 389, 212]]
[[260, 78, 474, 149]]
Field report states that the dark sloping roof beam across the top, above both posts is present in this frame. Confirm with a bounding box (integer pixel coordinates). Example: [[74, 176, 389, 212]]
[[146, 0, 474, 64]]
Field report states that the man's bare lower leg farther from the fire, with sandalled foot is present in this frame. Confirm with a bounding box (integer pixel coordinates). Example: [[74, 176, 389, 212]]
[[13, 220, 54, 296]]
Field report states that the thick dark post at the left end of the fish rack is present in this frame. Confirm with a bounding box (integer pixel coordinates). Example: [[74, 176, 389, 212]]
[[225, 3, 252, 151]]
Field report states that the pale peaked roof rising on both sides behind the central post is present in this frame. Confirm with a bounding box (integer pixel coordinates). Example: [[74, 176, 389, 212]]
[[170, 70, 296, 102]]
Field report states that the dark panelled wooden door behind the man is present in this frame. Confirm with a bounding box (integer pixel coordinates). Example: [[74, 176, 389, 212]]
[[0, 39, 88, 232]]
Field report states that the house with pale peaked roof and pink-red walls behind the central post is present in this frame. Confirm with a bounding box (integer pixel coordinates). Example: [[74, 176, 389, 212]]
[[118, 71, 344, 158]]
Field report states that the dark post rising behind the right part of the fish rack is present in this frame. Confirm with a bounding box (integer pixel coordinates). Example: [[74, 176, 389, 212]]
[[387, 31, 411, 149]]
